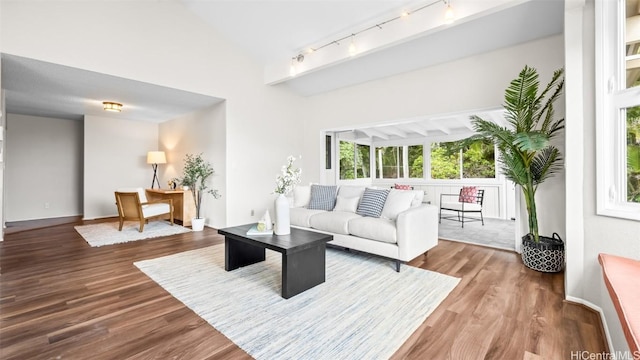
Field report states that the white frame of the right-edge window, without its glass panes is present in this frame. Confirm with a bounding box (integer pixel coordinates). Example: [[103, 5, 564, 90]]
[[595, 0, 640, 220]]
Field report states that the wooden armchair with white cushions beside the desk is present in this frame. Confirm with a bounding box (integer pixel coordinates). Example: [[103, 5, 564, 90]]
[[115, 188, 173, 232]]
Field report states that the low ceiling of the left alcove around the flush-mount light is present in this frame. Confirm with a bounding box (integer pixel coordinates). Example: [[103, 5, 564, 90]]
[[2, 54, 222, 123]]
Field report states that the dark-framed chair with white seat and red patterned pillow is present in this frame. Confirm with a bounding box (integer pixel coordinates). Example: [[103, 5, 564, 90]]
[[438, 186, 484, 228]]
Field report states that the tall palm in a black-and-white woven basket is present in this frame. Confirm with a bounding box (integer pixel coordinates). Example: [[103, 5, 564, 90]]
[[471, 66, 564, 272]]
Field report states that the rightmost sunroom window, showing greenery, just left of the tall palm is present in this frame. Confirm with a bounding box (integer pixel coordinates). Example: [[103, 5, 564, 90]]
[[431, 140, 496, 179]]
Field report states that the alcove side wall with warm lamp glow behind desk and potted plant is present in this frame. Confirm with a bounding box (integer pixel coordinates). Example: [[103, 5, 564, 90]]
[[160, 103, 229, 228]]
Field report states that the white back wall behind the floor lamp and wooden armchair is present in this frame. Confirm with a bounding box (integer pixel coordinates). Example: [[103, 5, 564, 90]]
[[84, 115, 158, 219]]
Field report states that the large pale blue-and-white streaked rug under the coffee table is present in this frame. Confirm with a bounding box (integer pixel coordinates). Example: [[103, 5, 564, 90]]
[[135, 245, 460, 360]]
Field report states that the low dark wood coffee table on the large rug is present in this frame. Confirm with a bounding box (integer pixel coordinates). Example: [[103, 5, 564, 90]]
[[218, 224, 333, 299]]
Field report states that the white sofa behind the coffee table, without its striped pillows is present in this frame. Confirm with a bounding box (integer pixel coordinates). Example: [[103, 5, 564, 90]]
[[290, 185, 438, 271]]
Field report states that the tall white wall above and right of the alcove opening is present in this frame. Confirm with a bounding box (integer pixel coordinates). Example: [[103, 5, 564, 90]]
[[0, 1, 306, 225]]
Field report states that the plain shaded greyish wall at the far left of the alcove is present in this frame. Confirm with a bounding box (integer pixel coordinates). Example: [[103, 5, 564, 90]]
[[4, 114, 82, 221]]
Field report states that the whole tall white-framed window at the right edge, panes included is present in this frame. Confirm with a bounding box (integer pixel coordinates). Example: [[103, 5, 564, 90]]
[[595, 0, 640, 220]]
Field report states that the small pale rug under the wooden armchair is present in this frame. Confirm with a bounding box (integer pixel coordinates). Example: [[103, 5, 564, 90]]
[[74, 221, 191, 247]]
